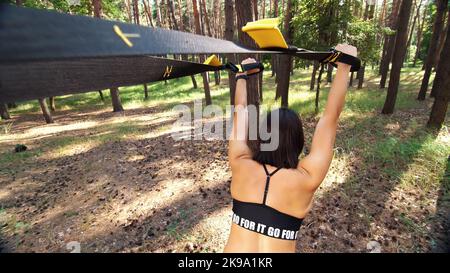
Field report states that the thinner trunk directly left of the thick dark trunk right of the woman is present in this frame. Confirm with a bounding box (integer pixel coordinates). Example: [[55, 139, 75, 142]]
[[380, 0, 400, 89]]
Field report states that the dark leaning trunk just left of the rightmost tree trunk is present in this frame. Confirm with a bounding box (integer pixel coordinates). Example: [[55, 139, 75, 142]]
[[417, 0, 448, 100]]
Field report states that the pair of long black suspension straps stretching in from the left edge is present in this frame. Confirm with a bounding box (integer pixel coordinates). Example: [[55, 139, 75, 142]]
[[0, 4, 359, 103]]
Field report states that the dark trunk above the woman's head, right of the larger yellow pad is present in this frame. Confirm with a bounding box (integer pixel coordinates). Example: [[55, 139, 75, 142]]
[[275, 0, 295, 107]]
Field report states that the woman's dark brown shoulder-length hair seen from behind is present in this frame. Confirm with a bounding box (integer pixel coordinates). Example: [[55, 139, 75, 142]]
[[253, 108, 305, 169]]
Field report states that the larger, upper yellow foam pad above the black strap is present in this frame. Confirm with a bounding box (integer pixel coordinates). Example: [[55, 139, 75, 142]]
[[242, 18, 288, 48]]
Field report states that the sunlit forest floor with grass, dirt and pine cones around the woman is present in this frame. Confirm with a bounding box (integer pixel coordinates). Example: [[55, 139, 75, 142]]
[[0, 65, 450, 252]]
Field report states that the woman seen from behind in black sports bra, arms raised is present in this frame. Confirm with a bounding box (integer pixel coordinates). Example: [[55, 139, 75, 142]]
[[224, 44, 357, 252]]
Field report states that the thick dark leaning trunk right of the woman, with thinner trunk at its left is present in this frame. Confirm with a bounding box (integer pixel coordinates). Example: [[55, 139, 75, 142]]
[[382, 0, 412, 114]]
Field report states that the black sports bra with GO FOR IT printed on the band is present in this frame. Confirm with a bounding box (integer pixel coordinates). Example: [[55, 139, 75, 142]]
[[232, 164, 303, 240]]
